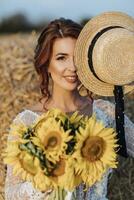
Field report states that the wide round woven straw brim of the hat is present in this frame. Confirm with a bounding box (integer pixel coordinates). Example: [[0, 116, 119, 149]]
[[74, 11, 134, 96]]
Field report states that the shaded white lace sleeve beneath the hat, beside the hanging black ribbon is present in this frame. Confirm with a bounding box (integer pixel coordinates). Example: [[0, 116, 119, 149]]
[[93, 99, 134, 157]]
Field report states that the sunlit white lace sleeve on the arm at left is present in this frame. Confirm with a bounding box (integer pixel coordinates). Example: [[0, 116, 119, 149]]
[[5, 110, 50, 200]]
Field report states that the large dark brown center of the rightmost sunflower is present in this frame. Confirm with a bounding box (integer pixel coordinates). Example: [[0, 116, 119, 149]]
[[81, 136, 106, 162]]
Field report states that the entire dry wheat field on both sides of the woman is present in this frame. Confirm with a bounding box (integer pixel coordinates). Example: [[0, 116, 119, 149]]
[[0, 32, 134, 200]]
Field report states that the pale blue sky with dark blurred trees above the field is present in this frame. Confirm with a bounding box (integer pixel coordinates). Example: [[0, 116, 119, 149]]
[[0, 0, 134, 33]]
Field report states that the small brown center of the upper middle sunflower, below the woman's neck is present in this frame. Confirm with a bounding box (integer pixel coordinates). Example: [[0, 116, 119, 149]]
[[44, 131, 61, 149]]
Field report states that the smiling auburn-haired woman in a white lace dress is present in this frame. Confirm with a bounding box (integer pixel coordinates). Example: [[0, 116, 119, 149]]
[[5, 18, 134, 200]]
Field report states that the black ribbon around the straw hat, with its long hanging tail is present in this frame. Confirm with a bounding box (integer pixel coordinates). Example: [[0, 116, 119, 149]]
[[88, 26, 128, 157]]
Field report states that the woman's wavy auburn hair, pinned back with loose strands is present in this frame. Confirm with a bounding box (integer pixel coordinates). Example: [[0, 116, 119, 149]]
[[34, 18, 93, 109]]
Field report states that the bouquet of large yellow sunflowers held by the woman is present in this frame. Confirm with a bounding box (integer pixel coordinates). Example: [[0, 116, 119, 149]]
[[4, 109, 118, 199]]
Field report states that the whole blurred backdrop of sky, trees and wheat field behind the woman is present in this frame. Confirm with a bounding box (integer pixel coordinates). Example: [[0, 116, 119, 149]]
[[0, 0, 134, 200]]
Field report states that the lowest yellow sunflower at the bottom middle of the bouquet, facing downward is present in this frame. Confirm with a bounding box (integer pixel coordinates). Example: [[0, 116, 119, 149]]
[[34, 157, 82, 191]]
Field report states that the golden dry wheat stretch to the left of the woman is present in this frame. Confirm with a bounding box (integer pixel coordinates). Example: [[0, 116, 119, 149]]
[[0, 32, 40, 199]]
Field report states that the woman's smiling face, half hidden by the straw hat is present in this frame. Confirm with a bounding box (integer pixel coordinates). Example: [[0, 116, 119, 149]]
[[48, 37, 78, 91]]
